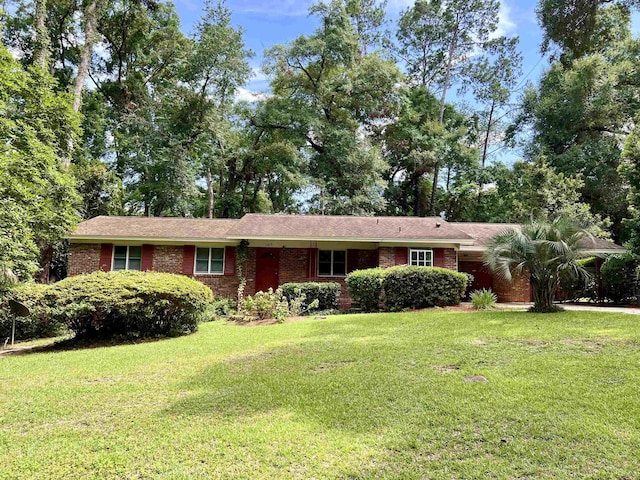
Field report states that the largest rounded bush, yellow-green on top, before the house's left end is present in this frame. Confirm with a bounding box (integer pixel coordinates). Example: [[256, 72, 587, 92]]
[[48, 271, 213, 338]]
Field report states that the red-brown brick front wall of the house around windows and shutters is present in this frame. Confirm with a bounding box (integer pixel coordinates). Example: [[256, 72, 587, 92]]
[[69, 243, 458, 309]]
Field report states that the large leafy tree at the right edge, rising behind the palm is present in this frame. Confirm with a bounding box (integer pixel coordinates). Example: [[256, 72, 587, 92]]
[[516, 7, 640, 241]]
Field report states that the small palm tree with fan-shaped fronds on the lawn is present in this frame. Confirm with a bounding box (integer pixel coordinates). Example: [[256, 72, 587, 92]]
[[484, 218, 591, 312]]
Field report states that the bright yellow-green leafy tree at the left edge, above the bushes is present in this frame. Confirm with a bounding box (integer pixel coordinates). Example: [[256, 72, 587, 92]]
[[0, 44, 79, 281]]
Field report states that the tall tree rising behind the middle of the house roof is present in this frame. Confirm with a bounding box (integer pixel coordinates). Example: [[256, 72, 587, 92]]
[[258, 0, 400, 213]]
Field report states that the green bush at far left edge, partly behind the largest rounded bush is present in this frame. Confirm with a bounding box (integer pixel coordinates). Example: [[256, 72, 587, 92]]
[[0, 283, 64, 343]]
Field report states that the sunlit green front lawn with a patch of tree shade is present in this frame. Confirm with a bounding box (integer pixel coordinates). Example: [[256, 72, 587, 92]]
[[0, 311, 640, 479]]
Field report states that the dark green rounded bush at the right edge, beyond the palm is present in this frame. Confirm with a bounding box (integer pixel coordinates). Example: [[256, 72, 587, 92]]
[[600, 253, 640, 303]]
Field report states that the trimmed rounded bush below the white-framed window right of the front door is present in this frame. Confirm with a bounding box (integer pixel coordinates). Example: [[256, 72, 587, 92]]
[[382, 266, 467, 311]]
